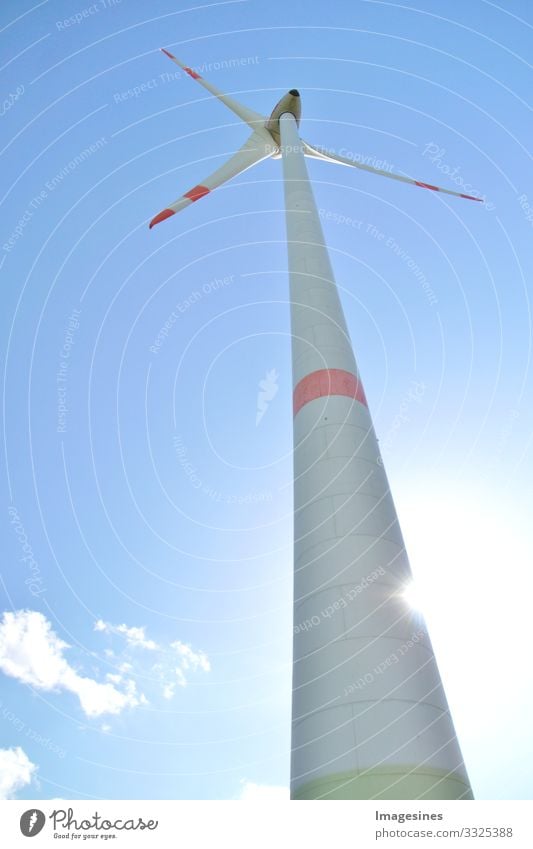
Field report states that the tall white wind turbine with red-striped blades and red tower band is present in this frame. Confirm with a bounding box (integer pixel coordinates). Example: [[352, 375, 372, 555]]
[[150, 50, 480, 799]]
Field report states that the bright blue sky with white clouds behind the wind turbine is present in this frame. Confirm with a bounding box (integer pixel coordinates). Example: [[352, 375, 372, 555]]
[[0, 0, 533, 799]]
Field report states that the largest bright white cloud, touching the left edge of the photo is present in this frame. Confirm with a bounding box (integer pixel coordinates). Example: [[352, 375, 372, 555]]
[[0, 610, 144, 716]]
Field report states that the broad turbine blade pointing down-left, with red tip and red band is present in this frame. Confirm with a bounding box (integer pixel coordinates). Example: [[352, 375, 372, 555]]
[[150, 130, 277, 229]]
